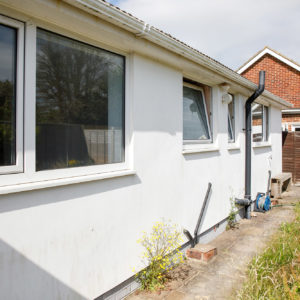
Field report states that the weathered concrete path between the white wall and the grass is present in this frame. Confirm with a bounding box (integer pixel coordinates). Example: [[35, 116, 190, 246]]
[[127, 187, 300, 300]]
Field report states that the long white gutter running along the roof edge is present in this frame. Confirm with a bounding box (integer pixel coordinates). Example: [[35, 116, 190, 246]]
[[62, 0, 292, 109]]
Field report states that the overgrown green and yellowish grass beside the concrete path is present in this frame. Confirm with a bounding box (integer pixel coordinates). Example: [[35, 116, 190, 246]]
[[236, 204, 300, 300]]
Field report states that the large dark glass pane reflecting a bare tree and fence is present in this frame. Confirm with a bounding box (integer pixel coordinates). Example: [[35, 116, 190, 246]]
[[36, 29, 125, 170]]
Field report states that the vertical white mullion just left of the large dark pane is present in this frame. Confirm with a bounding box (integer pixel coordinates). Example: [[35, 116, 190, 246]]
[[24, 22, 36, 175]]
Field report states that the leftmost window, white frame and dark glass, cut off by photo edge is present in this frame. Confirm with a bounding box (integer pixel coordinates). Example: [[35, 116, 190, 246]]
[[0, 16, 24, 173]]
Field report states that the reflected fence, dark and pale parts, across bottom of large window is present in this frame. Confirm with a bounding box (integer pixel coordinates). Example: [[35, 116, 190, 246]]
[[36, 124, 124, 170]]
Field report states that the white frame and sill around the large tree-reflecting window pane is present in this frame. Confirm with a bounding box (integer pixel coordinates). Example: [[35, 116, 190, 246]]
[[0, 14, 135, 190]]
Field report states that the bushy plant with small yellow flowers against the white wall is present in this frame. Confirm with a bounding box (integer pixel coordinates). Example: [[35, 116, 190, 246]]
[[136, 221, 184, 291]]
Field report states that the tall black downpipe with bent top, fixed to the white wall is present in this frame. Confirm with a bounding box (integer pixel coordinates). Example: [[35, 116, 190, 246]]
[[245, 71, 265, 219]]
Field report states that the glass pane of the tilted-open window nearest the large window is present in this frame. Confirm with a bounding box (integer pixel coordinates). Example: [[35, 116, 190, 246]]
[[183, 87, 210, 140]]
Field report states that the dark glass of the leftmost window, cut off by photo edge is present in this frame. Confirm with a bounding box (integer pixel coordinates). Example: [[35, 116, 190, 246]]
[[0, 24, 17, 166]]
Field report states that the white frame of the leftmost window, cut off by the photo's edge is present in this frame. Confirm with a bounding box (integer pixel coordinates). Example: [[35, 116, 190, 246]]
[[0, 15, 24, 174]]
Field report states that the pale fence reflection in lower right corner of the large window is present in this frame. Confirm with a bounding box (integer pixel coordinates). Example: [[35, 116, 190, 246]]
[[84, 128, 123, 164]]
